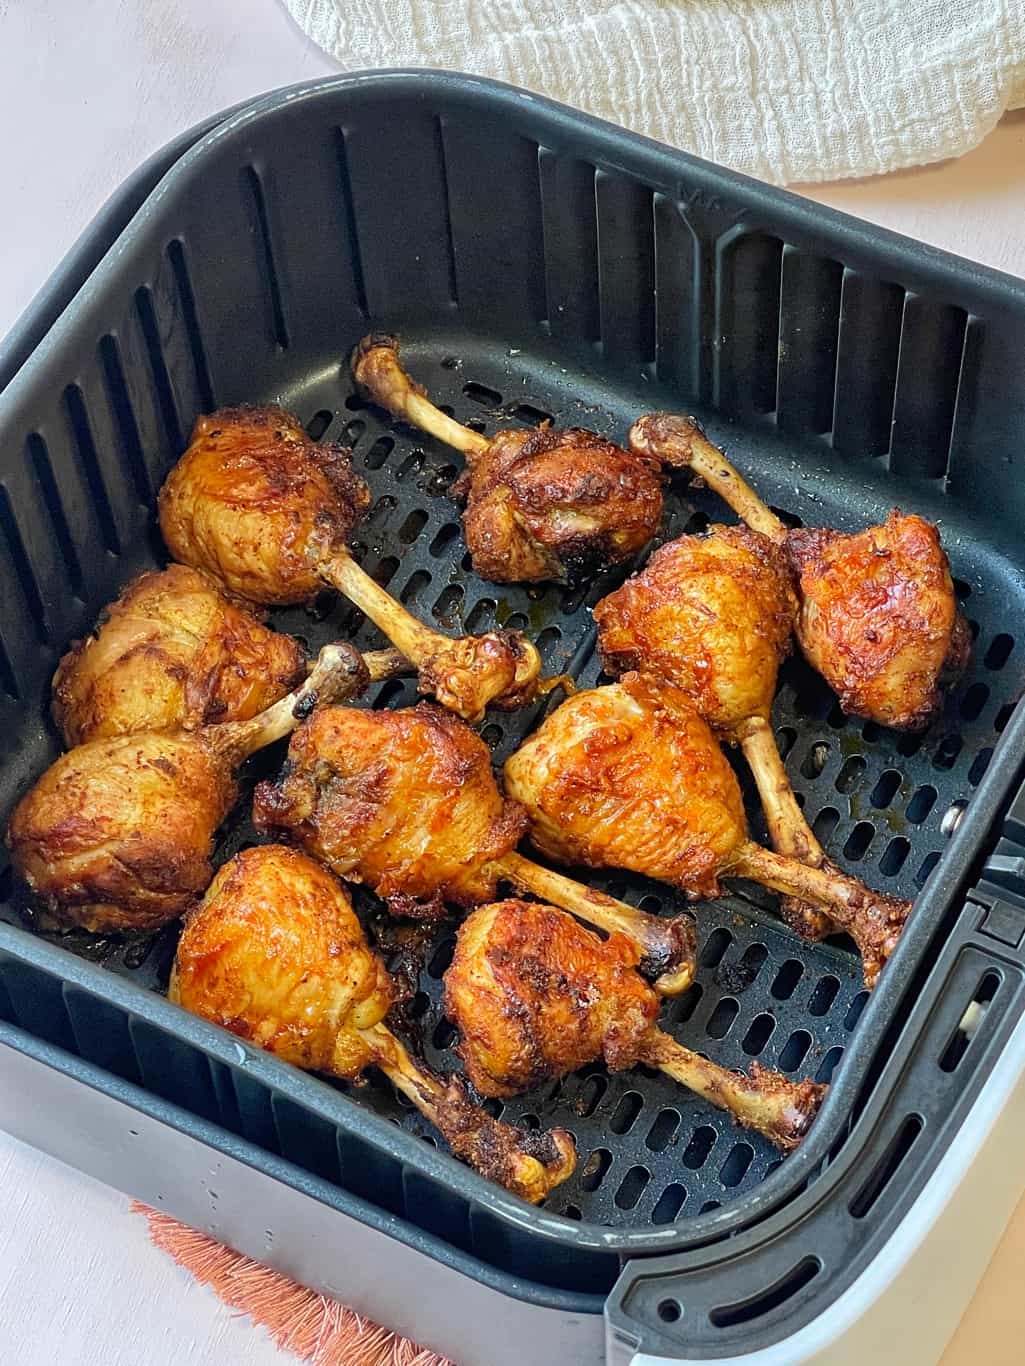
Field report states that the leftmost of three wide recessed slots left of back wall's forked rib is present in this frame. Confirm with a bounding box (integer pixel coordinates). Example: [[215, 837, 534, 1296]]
[[537, 148, 601, 343]]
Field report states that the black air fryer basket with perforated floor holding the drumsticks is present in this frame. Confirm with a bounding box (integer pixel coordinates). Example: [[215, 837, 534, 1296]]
[[0, 72, 1025, 1366]]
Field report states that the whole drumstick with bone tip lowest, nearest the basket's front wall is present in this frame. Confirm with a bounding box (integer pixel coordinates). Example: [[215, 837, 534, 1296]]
[[168, 844, 577, 1202]]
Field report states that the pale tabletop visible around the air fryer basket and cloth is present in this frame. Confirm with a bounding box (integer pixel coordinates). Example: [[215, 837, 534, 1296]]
[[0, 0, 1025, 1366]]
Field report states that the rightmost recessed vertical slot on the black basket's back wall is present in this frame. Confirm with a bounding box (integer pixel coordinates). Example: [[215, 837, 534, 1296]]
[[890, 294, 968, 478]]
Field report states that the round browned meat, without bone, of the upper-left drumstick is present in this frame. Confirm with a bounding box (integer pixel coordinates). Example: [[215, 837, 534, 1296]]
[[157, 407, 370, 605]]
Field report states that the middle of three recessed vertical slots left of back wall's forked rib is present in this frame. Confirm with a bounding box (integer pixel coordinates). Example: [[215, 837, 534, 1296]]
[[595, 171, 655, 365]]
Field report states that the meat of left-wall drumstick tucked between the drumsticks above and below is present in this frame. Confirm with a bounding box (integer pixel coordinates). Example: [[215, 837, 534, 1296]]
[[53, 564, 306, 747]]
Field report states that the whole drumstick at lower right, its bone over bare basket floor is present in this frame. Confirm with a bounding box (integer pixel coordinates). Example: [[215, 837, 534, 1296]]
[[444, 902, 827, 1152]]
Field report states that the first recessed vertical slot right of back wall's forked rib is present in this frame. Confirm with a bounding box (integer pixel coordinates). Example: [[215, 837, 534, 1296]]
[[716, 232, 783, 417]]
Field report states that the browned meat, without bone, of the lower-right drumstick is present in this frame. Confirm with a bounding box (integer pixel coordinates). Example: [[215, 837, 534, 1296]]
[[444, 900, 660, 1096]]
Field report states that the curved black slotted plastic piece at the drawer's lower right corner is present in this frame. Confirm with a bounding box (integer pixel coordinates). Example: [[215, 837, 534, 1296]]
[[605, 891, 1025, 1366]]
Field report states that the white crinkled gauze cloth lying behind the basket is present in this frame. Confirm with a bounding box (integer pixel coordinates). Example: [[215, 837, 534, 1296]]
[[284, 0, 1025, 184]]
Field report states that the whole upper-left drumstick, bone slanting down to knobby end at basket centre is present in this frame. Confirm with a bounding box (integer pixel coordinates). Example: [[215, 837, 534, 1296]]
[[159, 408, 541, 720]]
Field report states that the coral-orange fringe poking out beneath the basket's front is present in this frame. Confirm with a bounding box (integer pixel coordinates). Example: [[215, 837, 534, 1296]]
[[131, 1201, 452, 1366]]
